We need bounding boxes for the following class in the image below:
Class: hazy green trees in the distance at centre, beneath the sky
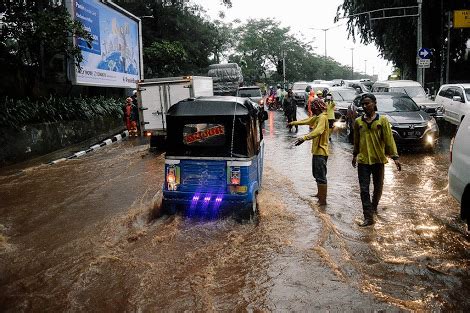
[229,18,362,83]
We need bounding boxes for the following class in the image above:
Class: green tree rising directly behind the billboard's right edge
[115,0,231,77]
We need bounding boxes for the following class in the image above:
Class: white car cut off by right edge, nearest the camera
[448,115,470,231]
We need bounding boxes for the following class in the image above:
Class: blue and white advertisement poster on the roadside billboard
[72,0,141,88]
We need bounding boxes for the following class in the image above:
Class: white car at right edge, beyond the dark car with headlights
[436,83,470,125]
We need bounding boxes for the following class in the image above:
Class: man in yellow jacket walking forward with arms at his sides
[352,93,401,227]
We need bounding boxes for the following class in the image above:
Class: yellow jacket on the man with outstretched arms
[292,112,329,156]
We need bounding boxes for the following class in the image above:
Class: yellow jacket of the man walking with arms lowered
[353,114,398,165]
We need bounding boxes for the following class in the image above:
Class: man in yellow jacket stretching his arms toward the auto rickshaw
[289,99,329,205]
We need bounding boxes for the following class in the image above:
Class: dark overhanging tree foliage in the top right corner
[338,0,470,82]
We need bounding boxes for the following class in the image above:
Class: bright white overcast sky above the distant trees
[191,0,392,80]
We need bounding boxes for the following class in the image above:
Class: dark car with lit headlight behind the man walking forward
[346,92,439,149]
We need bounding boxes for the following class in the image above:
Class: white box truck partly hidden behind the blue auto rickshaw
[137,76,214,148]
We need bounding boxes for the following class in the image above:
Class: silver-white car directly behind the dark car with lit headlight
[372,80,443,118]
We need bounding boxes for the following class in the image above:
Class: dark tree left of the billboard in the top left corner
[0,0,92,96]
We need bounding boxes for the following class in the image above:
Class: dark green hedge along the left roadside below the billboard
[0,96,124,129]
